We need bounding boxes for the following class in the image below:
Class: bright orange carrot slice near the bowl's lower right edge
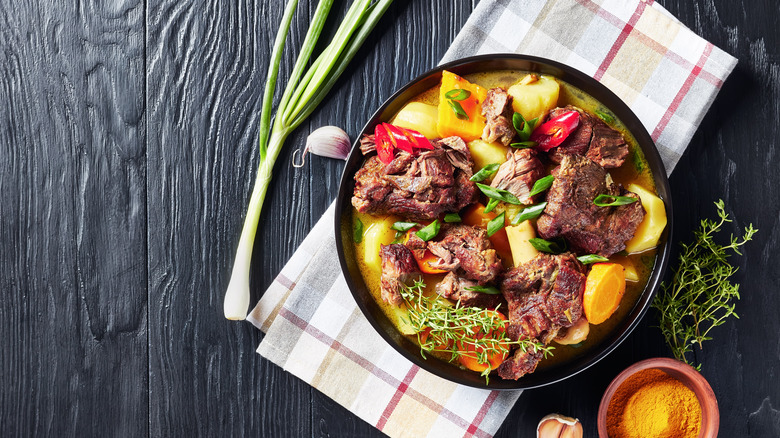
[582,263,626,324]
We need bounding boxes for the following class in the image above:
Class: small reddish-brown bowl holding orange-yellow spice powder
[598,357,720,438]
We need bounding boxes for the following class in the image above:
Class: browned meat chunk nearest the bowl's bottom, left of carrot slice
[498,253,586,379]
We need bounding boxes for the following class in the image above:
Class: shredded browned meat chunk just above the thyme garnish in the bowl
[428,224,502,285]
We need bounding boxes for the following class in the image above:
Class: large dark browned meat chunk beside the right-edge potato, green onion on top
[536,155,645,257]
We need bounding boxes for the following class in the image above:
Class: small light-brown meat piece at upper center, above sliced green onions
[490,149,544,204]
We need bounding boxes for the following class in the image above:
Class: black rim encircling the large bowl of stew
[334,53,673,390]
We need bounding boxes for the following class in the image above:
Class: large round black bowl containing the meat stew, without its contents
[335,54,673,389]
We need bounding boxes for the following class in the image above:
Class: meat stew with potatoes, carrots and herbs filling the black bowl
[351,71,666,380]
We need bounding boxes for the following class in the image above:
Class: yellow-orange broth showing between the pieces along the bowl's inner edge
[353,71,656,369]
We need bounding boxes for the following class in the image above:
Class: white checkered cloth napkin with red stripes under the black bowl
[248,0,736,437]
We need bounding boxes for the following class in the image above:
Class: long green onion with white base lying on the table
[224,0,392,320]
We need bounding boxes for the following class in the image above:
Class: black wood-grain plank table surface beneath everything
[0,0,780,437]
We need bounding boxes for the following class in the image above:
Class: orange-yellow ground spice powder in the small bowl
[607,369,701,438]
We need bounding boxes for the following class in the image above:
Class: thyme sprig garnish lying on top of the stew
[401,281,554,384]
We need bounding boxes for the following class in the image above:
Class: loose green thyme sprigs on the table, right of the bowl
[653,200,758,368]
